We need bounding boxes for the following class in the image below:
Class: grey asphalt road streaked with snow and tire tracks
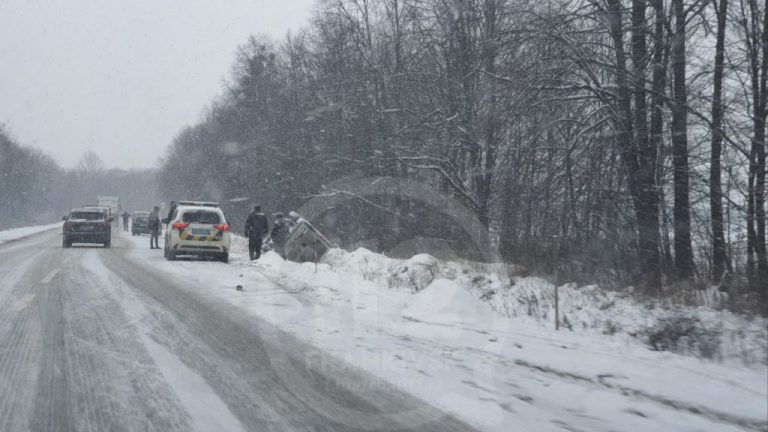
[0,230,471,431]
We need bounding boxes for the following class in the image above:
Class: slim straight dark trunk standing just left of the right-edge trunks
[709,0,728,282]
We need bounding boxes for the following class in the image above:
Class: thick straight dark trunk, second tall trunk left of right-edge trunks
[671,0,694,280]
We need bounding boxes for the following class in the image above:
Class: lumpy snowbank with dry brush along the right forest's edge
[322,248,768,369]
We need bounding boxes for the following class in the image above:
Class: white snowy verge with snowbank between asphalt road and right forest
[129,237,768,432]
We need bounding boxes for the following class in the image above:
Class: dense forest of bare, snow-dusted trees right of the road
[160,0,756,304]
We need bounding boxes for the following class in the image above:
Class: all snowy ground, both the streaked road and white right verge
[0,230,768,432]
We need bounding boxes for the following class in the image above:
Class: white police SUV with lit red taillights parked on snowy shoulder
[163,201,230,263]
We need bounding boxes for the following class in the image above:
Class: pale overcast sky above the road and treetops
[0,0,314,168]
